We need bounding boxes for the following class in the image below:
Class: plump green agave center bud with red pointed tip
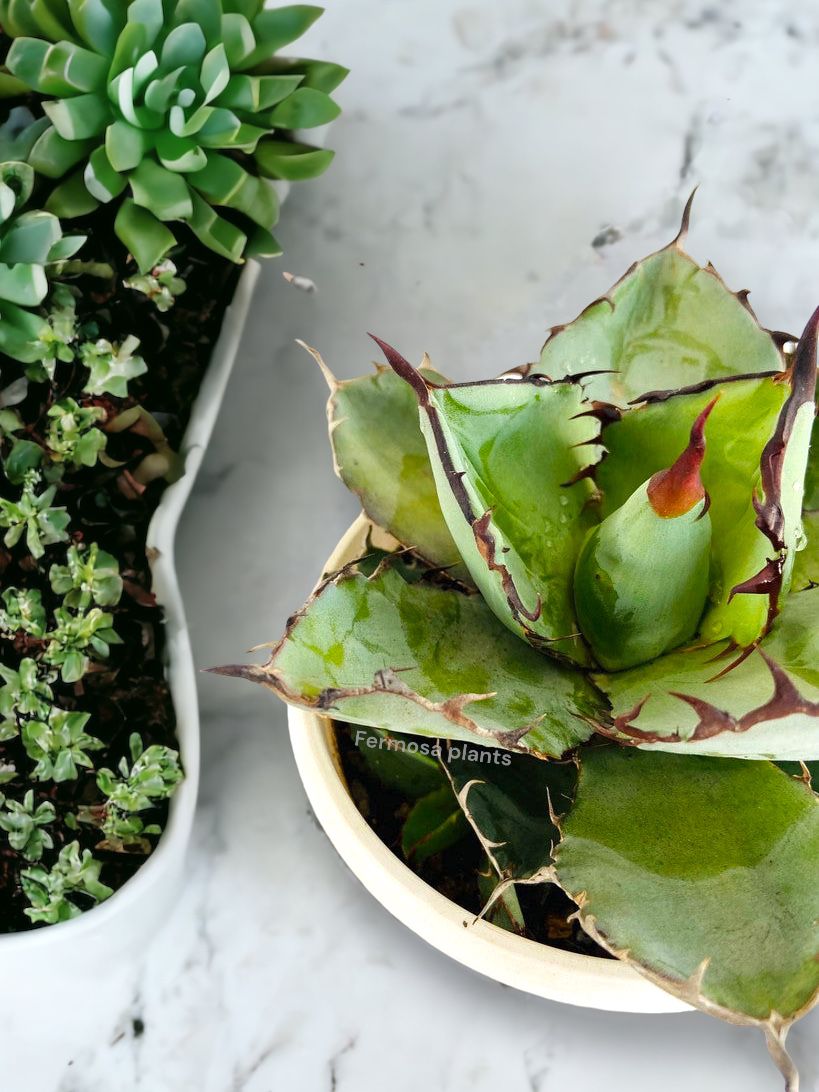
[574,399,716,672]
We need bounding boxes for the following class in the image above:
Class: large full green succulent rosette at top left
[0,0,346,274]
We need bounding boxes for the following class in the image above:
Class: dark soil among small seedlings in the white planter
[0,194,239,933]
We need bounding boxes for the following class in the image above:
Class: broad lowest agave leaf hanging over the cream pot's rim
[555,747,819,1088]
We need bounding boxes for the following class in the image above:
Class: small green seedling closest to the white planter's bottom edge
[20,842,114,925]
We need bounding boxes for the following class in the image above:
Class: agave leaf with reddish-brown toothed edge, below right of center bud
[594,589,819,761]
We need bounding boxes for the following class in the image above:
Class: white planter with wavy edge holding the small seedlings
[0,257,259,982]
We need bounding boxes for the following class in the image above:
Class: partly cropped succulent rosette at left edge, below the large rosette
[0,163,85,364]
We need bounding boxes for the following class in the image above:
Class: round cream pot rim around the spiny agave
[288,519,689,1012]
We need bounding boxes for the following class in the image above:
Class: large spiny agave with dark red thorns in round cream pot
[219,203,819,1089]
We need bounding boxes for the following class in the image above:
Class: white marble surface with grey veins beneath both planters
[11,0,819,1092]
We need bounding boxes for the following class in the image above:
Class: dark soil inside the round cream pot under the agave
[335,723,612,959]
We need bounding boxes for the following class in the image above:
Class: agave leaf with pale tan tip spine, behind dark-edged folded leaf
[309,349,461,566]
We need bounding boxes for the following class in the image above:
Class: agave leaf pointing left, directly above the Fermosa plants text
[224,559,600,756]
